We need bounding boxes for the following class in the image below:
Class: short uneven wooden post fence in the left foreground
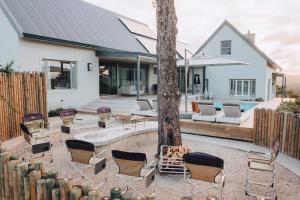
[0,149,103,200]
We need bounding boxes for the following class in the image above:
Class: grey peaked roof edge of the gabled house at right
[194,20,282,70]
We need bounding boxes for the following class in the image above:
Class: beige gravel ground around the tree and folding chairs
[4,129,300,200]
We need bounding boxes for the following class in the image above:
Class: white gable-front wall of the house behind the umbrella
[198,26,272,99]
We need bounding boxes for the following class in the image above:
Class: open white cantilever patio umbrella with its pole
[177,53,249,112]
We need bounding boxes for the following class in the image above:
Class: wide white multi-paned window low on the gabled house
[229,79,256,97]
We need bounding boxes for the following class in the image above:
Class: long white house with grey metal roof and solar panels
[0,0,186,109]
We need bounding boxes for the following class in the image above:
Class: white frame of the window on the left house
[42,58,78,91]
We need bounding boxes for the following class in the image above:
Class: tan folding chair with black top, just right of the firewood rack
[183,152,225,199]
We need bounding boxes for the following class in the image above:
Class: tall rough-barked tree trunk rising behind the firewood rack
[156,0,182,155]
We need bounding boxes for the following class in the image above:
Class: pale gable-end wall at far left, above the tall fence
[0,9,19,67]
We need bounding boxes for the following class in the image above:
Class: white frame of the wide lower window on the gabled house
[229,79,256,97]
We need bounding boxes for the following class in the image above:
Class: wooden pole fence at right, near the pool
[253,109,300,160]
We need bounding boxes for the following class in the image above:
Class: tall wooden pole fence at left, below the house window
[0,72,48,140]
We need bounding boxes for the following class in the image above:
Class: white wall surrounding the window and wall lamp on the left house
[19,39,99,110]
